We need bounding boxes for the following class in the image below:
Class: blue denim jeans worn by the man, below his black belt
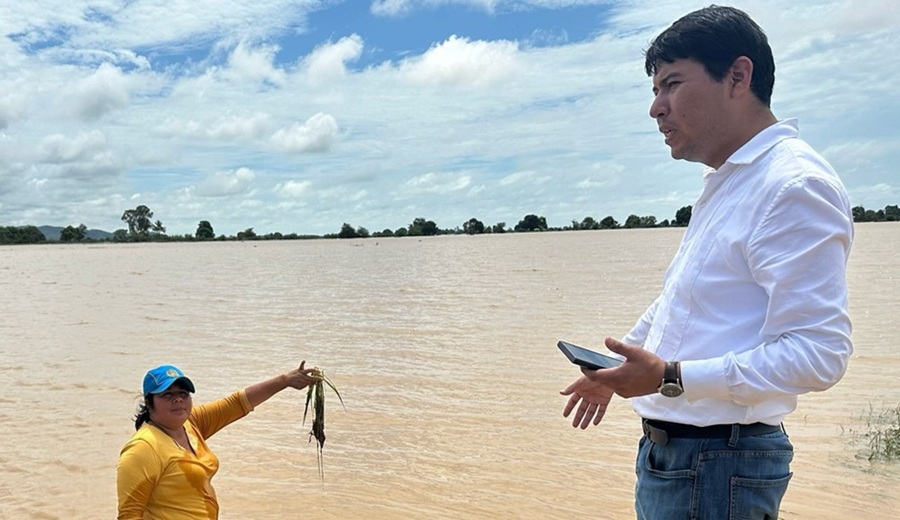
[635,424,794,520]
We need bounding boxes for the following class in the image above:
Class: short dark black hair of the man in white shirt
[644,5,775,106]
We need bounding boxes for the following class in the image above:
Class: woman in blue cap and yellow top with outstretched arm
[116,362,319,520]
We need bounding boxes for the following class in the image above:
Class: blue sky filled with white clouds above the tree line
[0,0,900,235]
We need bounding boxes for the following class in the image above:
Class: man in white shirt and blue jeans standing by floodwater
[562,6,853,520]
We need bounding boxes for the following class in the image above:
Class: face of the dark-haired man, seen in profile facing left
[650,59,733,168]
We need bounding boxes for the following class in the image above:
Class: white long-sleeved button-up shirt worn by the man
[623,120,853,426]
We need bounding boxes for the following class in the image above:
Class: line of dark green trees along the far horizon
[0,205,900,244]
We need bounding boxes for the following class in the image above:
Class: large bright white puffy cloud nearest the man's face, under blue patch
[400,35,518,86]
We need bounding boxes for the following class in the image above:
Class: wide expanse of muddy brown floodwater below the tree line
[0,224,900,520]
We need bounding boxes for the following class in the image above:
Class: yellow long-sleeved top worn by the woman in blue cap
[116,390,253,520]
